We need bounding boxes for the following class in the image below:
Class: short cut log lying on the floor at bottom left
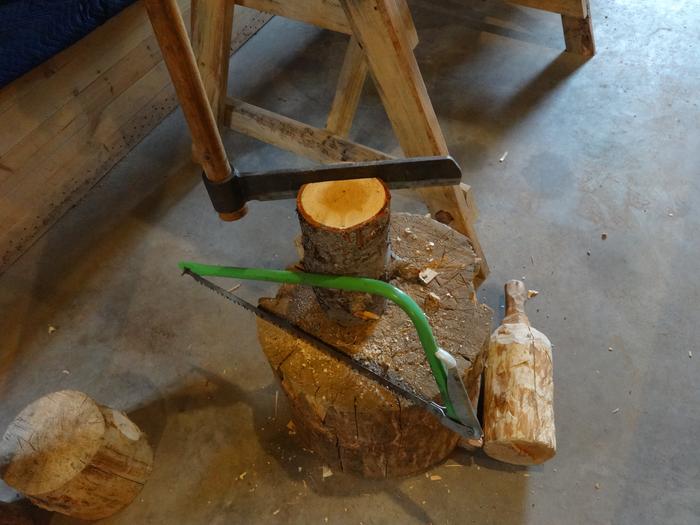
[0,390,153,520]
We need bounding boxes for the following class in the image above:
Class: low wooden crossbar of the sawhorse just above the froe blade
[226,99,391,163]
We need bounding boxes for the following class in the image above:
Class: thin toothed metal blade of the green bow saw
[183,270,456,426]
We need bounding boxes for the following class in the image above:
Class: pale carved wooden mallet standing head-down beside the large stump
[484,281,557,465]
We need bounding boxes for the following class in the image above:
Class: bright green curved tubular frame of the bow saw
[178,262,457,419]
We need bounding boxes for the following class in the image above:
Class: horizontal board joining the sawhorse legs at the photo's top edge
[235,0,352,35]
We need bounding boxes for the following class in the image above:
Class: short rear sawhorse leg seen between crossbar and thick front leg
[326,36,368,137]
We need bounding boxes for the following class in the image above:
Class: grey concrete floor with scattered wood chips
[0,0,700,525]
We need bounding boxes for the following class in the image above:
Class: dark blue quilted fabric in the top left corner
[0,0,135,87]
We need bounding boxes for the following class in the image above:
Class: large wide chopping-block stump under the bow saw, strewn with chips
[258,214,492,478]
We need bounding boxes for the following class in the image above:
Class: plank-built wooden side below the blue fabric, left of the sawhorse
[0,0,271,273]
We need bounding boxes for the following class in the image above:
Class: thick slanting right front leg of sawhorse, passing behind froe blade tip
[342,0,488,284]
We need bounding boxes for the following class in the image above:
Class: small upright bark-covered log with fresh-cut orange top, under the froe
[297,179,391,325]
